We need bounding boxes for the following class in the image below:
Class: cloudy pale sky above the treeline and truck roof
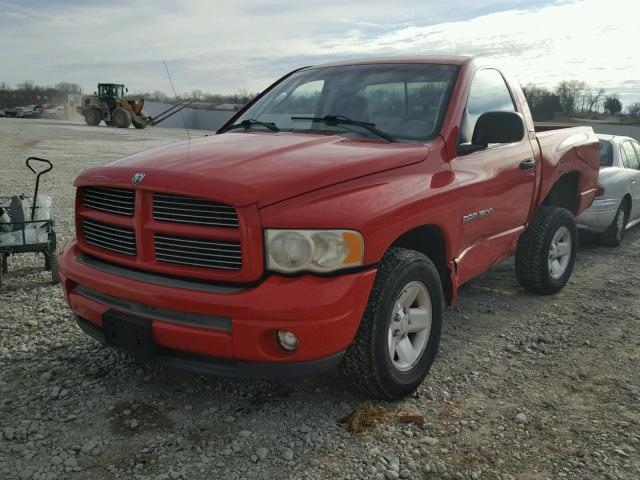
[0,0,640,104]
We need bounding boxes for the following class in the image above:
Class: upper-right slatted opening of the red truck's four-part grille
[153,193,238,228]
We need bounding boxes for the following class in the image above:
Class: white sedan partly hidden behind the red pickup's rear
[577,134,640,247]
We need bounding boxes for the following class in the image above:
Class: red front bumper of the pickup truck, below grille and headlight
[59,240,376,377]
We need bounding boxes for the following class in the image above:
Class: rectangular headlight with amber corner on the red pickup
[265,230,364,273]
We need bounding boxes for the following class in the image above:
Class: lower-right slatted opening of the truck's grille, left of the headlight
[154,234,242,270]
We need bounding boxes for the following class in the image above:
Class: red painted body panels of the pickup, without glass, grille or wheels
[60,57,599,372]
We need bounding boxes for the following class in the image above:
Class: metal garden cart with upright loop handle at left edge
[0,157,59,287]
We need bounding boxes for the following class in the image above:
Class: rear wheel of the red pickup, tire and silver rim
[516,207,578,295]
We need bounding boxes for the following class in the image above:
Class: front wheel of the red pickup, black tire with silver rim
[340,248,444,400]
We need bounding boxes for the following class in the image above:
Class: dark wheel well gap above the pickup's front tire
[391,225,451,298]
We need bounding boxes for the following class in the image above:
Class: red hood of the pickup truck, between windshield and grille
[76,132,428,207]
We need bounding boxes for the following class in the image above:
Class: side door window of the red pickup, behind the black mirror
[459,68,516,143]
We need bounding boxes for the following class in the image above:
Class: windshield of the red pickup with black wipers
[230,64,458,142]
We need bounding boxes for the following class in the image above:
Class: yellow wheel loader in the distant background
[77,83,194,128]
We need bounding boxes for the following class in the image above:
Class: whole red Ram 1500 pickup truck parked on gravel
[60,57,599,399]
